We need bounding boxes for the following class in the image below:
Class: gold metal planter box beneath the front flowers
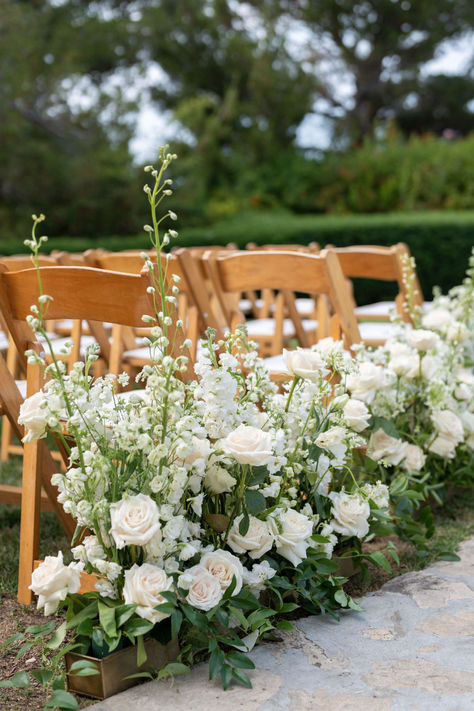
[65,639,179,700]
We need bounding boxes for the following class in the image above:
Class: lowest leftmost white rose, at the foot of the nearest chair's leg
[29,552,84,615]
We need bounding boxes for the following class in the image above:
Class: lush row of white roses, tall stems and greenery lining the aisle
[8,149,473,708]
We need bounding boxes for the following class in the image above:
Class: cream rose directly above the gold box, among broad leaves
[123,563,173,623]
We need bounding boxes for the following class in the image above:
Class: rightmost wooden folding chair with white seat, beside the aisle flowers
[325,243,423,346]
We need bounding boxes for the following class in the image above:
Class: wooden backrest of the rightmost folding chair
[325,242,423,319]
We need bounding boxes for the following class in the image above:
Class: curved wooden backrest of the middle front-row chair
[203,250,360,346]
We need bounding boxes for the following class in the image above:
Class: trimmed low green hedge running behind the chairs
[0,211,474,302]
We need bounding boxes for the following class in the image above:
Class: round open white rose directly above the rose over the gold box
[110,494,160,548]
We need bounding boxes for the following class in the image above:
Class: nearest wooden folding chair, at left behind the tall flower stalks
[0,266,192,603]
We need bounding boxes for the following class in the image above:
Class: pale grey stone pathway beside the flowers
[90,539,474,711]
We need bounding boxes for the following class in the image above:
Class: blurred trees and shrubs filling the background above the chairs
[0,0,474,272]
